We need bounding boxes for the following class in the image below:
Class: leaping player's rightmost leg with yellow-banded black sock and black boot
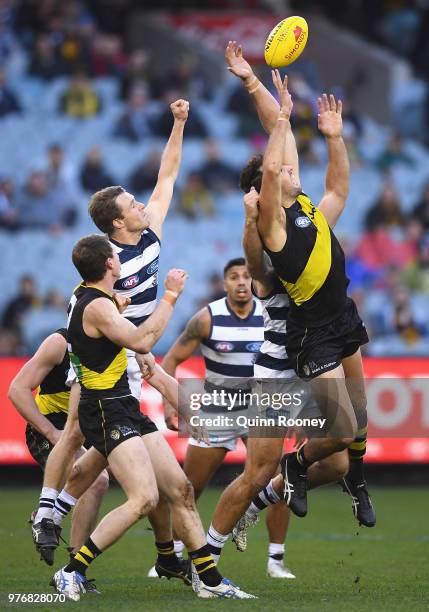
[342,349,376,527]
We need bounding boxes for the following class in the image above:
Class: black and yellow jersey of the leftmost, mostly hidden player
[34,328,70,415]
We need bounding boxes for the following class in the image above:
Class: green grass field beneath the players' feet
[0,487,429,612]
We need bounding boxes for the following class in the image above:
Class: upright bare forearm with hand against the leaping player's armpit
[243,187,274,295]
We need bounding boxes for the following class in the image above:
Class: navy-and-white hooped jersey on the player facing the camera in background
[201,298,264,385]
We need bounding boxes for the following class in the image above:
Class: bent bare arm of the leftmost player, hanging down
[8,334,67,444]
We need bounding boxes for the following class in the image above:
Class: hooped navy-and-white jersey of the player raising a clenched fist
[110,228,161,325]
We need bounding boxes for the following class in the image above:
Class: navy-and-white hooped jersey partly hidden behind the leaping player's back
[254,282,295,378]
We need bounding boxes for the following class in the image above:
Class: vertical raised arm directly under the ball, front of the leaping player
[257,70,292,251]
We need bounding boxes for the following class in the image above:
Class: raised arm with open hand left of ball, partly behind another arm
[225,40,299,179]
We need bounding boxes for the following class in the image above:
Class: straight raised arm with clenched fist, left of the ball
[146,100,189,238]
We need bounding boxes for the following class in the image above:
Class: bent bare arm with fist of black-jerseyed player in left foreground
[83,269,187,353]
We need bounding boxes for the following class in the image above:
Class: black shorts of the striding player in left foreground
[79,395,158,457]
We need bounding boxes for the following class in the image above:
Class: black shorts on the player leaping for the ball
[286,298,369,380]
